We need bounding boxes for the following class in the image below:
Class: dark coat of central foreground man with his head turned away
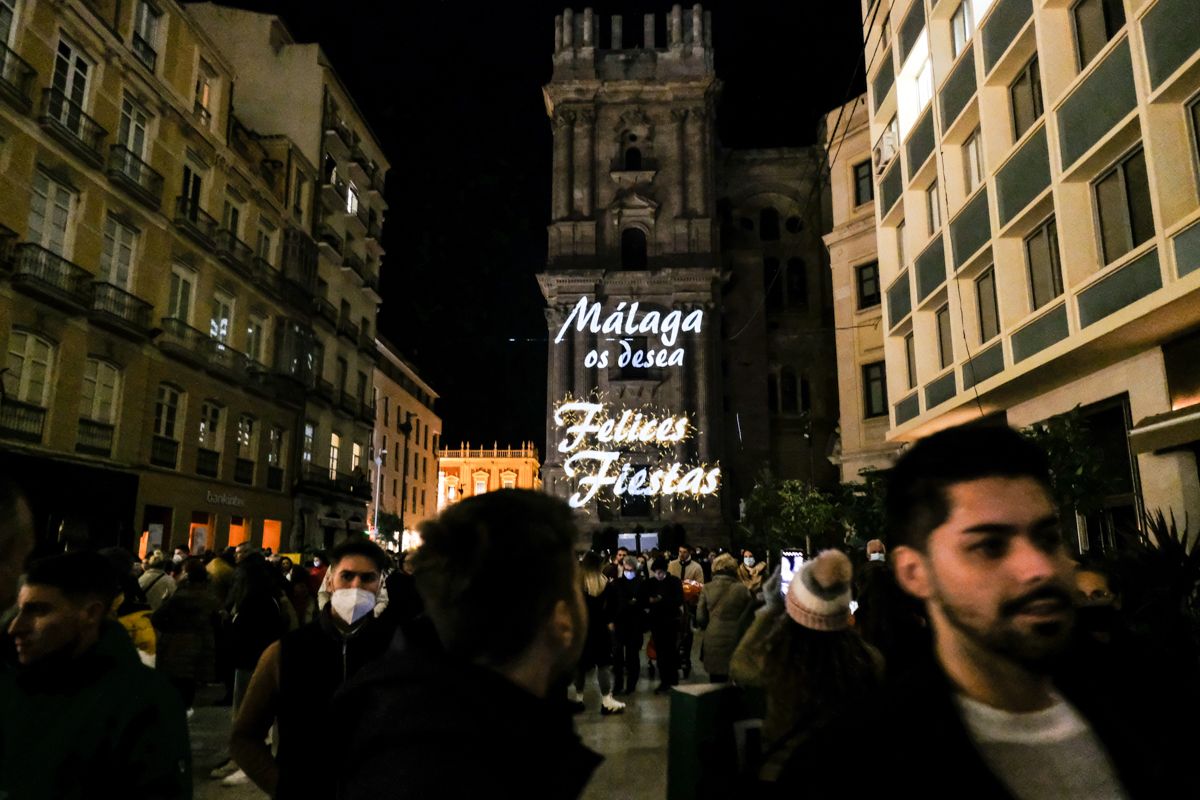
[336,648,602,800]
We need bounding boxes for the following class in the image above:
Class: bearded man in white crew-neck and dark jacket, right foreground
[781,426,1200,799]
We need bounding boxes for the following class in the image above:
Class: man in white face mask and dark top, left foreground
[230,539,395,800]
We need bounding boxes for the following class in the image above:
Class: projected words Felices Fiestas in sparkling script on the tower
[554,397,721,509]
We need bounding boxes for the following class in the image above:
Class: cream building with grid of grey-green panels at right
[863,0,1200,551]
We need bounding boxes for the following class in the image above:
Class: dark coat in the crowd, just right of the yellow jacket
[150,581,220,682]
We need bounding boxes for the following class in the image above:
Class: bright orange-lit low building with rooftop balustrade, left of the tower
[437,443,542,511]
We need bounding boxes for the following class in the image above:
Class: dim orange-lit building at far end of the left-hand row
[371,339,442,533]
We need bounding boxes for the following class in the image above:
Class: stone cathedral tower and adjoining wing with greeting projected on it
[539,6,836,543]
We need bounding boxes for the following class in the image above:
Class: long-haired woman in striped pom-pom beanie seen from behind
[730,551,883,781]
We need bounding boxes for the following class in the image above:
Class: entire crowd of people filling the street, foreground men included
[0,427,1200,799]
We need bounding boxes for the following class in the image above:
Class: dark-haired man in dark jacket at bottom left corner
[0,553,192,800]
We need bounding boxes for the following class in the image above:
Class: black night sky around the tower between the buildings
[216,0,863,447]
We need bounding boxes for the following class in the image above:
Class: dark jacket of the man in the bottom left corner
[0,620,192,800]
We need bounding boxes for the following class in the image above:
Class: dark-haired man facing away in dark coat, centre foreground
[326,489,601,800]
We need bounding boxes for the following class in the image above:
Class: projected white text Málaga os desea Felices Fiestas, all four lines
[554,297,721,509]
